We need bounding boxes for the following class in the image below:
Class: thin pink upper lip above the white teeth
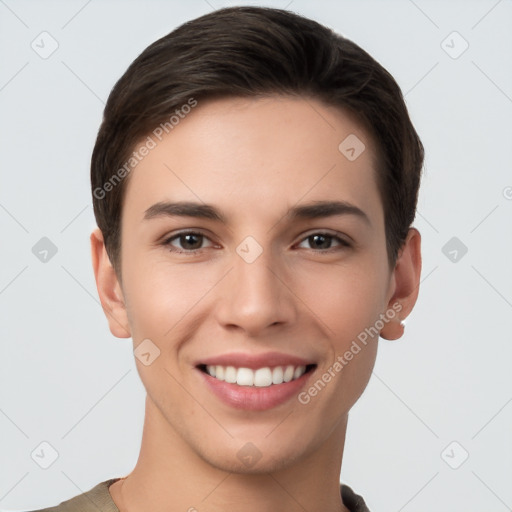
[195,352,316,370]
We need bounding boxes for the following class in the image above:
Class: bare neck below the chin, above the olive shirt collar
[110,397,349,512]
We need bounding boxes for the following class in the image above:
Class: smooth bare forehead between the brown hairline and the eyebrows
[123,96,383,229]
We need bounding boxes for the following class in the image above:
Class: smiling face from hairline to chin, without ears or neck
[109,97,394,472]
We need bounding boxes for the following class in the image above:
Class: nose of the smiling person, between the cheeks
[216,250,297,336]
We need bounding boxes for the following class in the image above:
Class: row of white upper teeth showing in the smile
[206,365,306,387]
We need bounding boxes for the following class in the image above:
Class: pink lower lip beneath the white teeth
[197,368,315,411]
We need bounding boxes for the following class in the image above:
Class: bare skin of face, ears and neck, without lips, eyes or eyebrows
[91,96,421,512]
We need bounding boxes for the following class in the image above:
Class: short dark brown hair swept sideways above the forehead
[91,7,424,278]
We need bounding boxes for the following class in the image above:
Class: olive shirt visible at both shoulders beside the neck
[31,478,370,512]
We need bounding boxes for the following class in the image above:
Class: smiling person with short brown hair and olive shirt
[29,7,424,512]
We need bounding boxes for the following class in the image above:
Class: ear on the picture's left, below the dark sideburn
[90,228,131,338]
